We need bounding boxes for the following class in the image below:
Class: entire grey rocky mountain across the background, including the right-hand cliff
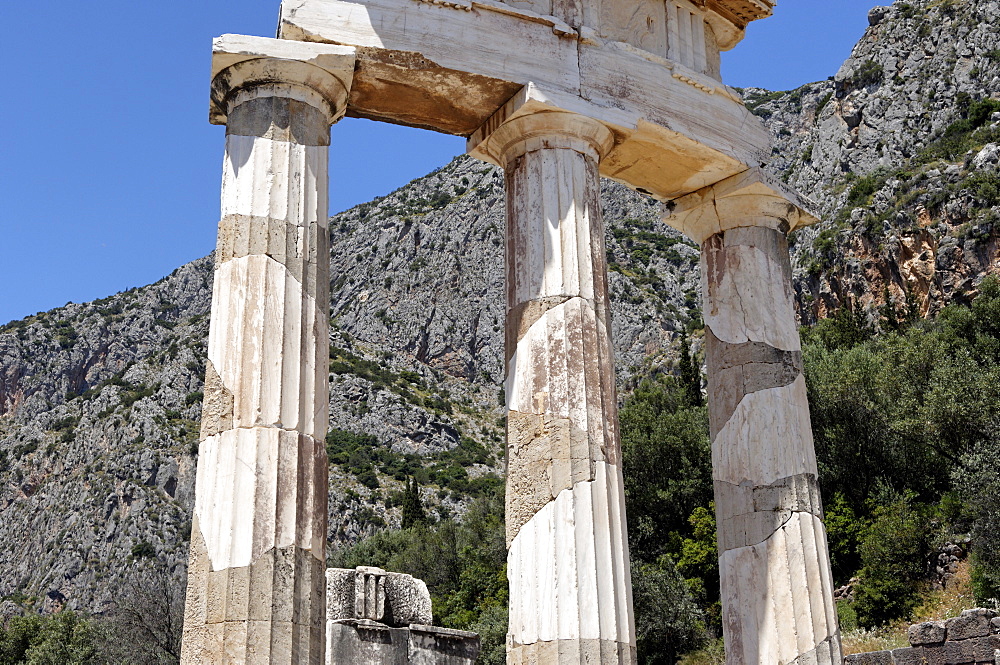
[0,0,1000,624]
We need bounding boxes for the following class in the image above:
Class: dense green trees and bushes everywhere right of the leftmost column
[333,278,1000,665]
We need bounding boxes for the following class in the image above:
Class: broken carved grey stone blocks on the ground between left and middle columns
[326,566,479,665]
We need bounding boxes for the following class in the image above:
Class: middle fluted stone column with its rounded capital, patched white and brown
[474,112,635,665]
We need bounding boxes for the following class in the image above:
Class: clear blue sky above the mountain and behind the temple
[0,0,876,324]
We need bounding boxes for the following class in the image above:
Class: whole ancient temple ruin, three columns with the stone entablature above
[182,0,841,665]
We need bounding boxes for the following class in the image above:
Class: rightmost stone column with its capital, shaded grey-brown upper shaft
[667,171,842,665]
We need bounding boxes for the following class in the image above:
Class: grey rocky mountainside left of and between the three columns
[0,157,698,613]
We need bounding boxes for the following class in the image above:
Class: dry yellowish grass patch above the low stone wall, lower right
[843,561,976,655]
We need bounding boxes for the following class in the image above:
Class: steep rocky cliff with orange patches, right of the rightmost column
[745,0,1000,322]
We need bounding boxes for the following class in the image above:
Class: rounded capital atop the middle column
[478,111,615,168]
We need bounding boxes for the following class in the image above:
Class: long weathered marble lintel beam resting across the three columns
[279,0,771,201]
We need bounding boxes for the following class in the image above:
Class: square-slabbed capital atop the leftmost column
[209,35,356,125]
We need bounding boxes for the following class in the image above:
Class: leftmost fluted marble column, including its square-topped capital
[181,36,354,665]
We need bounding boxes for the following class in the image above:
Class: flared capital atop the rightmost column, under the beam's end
[663,168,819,244]
